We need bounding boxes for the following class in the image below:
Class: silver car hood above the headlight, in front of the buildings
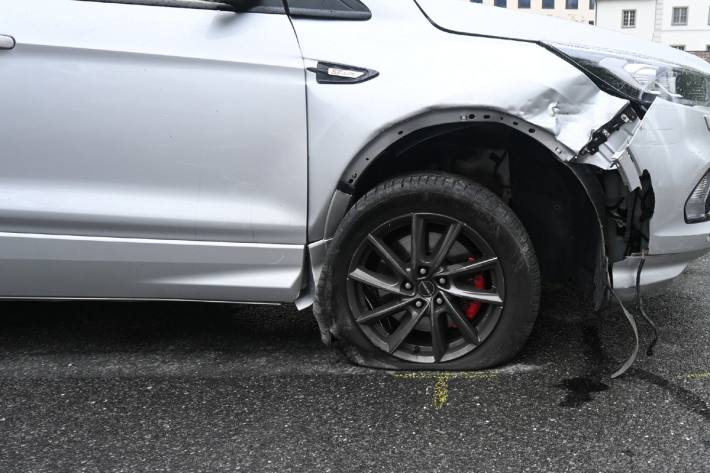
[415,0,710,74]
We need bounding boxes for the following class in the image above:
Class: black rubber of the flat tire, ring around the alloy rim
[322,176,539,370]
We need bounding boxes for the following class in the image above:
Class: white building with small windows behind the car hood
[596,0,710,51]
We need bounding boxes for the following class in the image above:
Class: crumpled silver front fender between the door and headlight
[293,0,628,241]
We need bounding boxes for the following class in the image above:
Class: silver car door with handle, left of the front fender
[0,0,307,301]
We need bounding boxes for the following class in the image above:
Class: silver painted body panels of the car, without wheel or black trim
[0,0,710,302]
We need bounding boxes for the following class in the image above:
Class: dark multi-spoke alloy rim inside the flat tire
[347,213,505,363]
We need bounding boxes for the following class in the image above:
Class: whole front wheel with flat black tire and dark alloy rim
[314,173,540,370]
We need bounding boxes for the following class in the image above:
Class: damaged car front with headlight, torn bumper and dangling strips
[551,43,710,377]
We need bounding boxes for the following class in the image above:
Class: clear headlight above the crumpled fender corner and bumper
[553,45,710,106]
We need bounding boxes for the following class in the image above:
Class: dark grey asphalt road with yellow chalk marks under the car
[0,258,710,473]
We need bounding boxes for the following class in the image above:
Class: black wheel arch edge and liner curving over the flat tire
[302,107,608,307]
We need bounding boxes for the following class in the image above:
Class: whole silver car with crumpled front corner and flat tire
[0,0,710,369]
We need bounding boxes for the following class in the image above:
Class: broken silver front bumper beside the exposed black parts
[612,100,710,298]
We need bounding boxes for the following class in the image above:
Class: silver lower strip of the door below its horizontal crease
[0,233,303,302]
